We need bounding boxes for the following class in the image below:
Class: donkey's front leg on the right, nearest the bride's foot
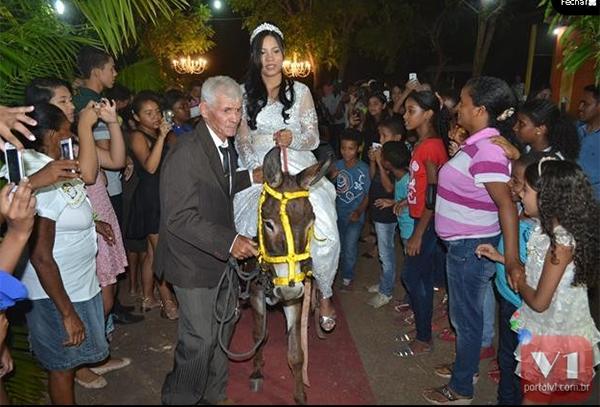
[283,302,308,404]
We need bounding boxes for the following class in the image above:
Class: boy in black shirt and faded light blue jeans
[367,117,404,308]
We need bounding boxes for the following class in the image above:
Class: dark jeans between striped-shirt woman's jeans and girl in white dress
[498,295,523,406]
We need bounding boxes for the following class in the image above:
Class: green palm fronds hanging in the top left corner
[0,0,195,105]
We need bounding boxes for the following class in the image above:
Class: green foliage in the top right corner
[539,0,600,84]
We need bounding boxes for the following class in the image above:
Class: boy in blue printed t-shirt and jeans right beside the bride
[331,129,371,291]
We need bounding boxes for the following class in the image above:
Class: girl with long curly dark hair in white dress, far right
[509,159,600,404]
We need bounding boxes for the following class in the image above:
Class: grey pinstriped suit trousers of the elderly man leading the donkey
[162,279,237,405]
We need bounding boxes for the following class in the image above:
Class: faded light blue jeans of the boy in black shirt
[373,222,398,297]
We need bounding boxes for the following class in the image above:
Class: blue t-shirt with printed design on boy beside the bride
[335,160,371,222]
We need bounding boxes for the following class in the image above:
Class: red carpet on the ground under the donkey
[227,303,375,405]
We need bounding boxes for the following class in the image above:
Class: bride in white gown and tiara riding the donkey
[234,23,340,332]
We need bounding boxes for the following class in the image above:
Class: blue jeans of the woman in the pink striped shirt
[445,236,499,397]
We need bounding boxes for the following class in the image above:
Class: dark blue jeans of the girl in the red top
[402,219,438,342]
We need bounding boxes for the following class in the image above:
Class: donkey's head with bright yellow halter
[258,147,332,300]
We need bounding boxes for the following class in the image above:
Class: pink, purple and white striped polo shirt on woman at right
[435,128,510,240]
